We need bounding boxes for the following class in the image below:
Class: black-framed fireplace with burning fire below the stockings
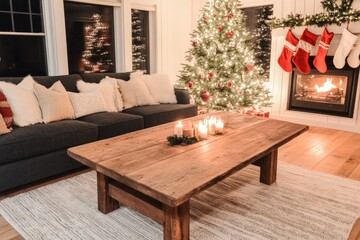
[288,57,359,118]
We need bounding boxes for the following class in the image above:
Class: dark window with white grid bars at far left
[0,0,47,76]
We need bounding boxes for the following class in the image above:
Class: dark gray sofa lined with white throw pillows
[0,73,197,192]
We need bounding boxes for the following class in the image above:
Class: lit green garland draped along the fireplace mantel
[267,0,360,28]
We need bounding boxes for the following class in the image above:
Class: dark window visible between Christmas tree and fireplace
[243,5,273,77]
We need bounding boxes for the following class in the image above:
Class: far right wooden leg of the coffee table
[259,149,278,185]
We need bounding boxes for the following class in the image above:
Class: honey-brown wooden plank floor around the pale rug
[0,127,360,240]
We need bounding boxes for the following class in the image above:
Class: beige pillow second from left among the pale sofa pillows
[34,81,75,123]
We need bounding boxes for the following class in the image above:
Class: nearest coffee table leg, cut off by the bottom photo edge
[163,200,190,240]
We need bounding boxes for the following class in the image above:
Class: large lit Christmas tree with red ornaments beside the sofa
[179,0,270,110]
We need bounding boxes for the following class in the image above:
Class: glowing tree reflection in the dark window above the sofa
[81,13,113,72]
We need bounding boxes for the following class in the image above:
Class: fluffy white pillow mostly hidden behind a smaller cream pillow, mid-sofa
[76,80,118,112]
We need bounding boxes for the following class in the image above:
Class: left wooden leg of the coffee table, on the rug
[97,172,119,214]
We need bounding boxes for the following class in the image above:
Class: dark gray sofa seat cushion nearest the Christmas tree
[123,104,197,128]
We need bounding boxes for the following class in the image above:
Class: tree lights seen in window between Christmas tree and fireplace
[254,5,273,77]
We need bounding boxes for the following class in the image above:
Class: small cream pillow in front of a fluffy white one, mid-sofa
[68,90,107,118]
